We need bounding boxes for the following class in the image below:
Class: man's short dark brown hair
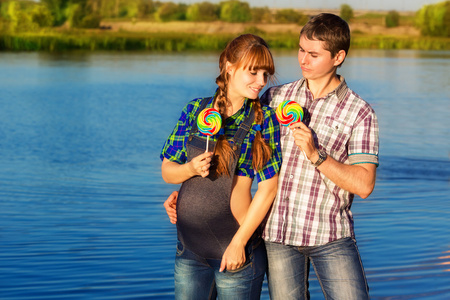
[300,13,350,63]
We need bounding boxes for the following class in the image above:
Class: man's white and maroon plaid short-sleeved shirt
[261,76,378,246]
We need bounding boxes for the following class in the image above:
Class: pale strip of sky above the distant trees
[174,0,444,11]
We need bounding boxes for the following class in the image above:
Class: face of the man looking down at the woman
[298,35,340,80]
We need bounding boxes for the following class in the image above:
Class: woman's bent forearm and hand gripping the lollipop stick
[161,152,213,184]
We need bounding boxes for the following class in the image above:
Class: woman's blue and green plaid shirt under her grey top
[160,98,281,182]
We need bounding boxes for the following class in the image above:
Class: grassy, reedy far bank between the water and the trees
[0,16,450,52]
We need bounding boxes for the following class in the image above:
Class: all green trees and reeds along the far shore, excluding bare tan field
[0,0,450,51]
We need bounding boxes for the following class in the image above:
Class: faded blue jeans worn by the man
[265,238,369,300]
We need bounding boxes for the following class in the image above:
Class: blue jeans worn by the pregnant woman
[175,238,267,300]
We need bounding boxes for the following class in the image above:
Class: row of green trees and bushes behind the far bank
[0,0,450,37]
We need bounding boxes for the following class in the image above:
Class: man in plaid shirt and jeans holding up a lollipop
[261,14,378,300]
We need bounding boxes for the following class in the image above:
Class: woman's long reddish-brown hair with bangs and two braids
[214,34,275,176]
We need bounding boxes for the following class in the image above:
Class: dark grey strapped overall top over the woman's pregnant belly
[177,98,254,259]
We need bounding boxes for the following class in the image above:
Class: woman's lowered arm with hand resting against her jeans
[220,175,278,272]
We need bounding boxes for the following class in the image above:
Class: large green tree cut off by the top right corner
[415,1,450,37]
